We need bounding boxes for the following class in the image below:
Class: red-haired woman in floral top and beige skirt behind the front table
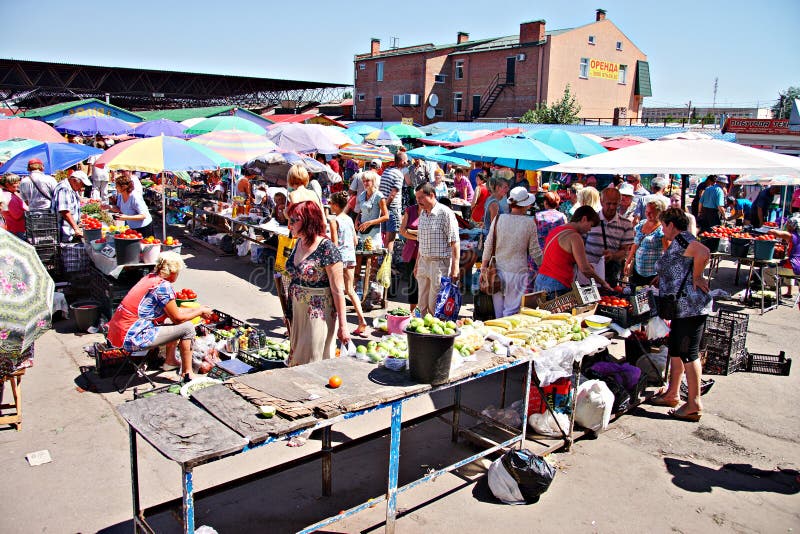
[286,201,350,366]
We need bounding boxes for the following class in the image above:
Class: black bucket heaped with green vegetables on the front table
[406,330,460,386]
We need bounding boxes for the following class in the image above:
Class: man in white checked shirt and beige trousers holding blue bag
[414,182,460,315]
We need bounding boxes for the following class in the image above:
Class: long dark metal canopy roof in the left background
[0,59,352,111]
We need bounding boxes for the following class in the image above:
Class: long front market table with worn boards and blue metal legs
[118,350,533,534]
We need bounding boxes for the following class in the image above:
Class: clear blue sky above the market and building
[0,0,800,107]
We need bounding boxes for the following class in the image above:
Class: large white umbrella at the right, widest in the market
[540,139,800,176]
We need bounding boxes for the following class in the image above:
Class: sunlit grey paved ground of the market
[0,240,800,533]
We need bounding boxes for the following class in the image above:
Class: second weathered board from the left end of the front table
[194,384,316,444]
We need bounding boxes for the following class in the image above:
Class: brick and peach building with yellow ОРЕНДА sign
[353,9,651,124]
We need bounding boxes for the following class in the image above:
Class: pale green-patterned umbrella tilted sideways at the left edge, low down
[0,229,55,374]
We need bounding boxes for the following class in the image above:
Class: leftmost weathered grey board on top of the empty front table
[117,393,247,464]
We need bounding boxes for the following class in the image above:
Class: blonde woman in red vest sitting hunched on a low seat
[108,252,213,382]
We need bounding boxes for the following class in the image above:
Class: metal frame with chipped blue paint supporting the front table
[129,359,533,534]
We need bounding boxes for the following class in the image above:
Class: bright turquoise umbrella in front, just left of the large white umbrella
[445,135,575,171]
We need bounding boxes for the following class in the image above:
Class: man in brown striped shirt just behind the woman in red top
[586,187,633,286]
